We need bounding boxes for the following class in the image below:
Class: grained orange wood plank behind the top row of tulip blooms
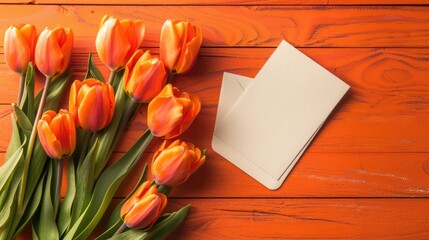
[0,5,429,48]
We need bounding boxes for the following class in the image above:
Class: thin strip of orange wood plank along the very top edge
[2,0,428,6]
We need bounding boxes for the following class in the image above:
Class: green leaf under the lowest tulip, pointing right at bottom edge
[110,205,191,240]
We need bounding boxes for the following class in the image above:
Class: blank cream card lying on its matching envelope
[212,41,349,189]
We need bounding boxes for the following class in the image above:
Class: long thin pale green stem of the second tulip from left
[18,77,51,212]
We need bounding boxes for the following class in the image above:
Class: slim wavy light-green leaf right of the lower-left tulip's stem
[57,158,76,236]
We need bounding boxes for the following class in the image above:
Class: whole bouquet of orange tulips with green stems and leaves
[0,16,205,239]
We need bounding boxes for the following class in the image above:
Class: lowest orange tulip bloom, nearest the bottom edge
[121,181,167,229]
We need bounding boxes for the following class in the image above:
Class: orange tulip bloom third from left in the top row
[95,15,145,70]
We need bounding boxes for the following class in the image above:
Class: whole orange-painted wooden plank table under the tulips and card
[0,0,429,239]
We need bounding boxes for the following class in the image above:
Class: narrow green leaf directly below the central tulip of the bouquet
[71,141,99,224]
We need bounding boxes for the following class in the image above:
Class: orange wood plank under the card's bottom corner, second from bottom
[113,153,429,198]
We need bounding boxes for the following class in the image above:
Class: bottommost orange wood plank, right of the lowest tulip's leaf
[155,199,429,240]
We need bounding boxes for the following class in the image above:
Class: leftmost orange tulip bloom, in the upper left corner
[4,24,37,74]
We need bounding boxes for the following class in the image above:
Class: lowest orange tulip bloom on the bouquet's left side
[37,109,76,160]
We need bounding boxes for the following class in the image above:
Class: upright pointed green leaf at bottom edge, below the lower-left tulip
[36,161,60,240]
